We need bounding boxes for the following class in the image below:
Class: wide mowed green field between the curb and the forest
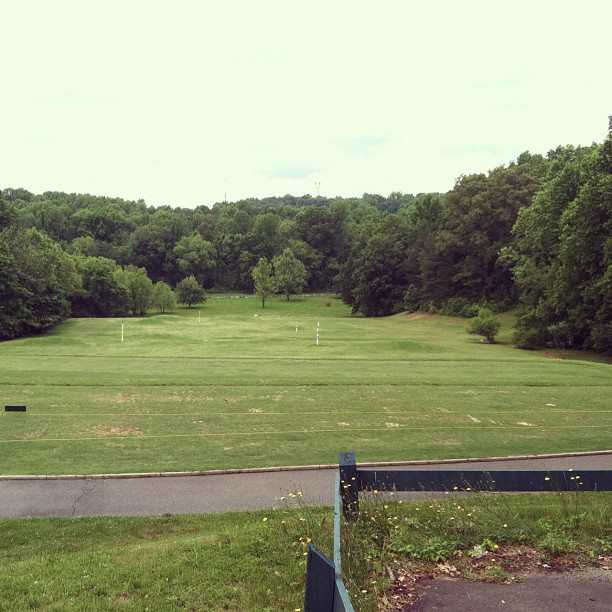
[0,296,612,474]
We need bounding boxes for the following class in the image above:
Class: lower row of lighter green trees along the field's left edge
[0,227,206,340]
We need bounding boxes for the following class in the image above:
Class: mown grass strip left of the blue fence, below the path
[0,510,331,611]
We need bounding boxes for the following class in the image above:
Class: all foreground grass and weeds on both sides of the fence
[0,493,612,612]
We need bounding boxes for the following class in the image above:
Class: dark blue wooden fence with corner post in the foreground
[304,452,612,612]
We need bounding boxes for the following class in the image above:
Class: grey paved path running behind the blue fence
[0,453,612,518]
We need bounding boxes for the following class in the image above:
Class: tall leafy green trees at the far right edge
[502,136,612,354]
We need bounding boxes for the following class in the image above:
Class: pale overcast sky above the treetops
[0,0,612,206]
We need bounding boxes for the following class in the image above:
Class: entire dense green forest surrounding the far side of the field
[0,124,612,352]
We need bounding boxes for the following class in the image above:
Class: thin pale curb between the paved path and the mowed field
[0,449,612,481]
